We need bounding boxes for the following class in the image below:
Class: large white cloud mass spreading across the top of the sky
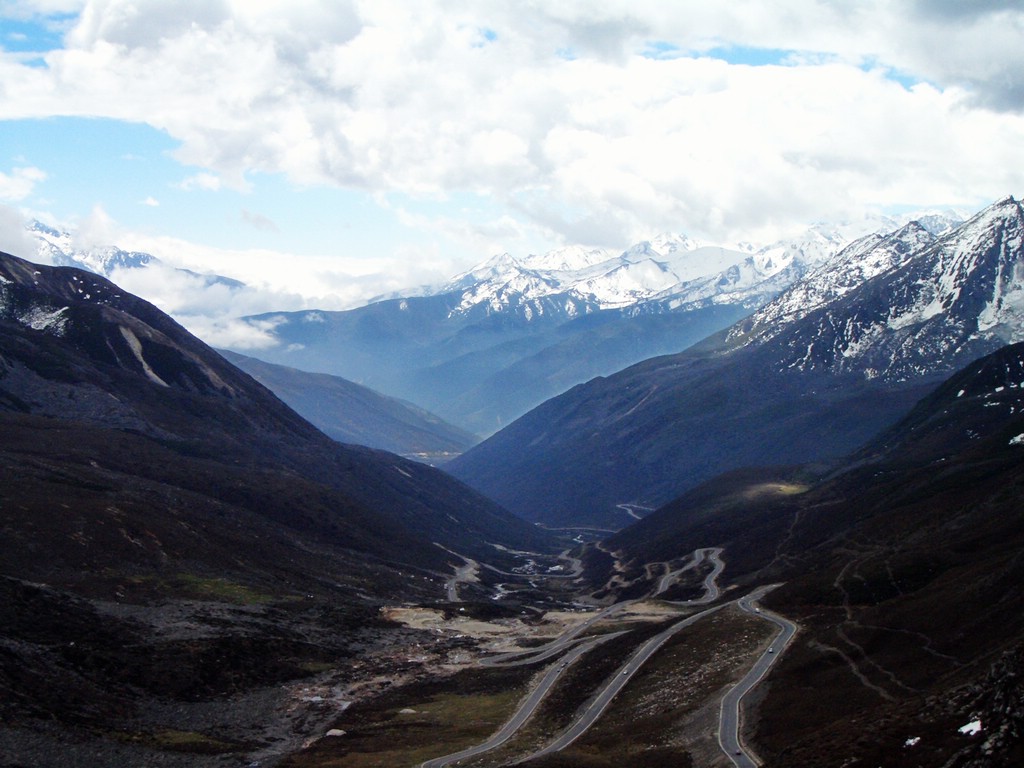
[0,0,1024,252]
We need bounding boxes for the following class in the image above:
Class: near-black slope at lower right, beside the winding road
[605,344,1024,768]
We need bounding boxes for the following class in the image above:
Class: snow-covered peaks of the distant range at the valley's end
[423,212,961,319]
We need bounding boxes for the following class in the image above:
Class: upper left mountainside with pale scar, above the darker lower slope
[0,249,543,555]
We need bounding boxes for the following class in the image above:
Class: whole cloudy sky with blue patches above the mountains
[0,0,1024,341]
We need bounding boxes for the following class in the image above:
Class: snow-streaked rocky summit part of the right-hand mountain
[734,198,1024,382]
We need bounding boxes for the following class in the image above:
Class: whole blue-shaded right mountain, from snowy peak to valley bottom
[447,199,1024,526]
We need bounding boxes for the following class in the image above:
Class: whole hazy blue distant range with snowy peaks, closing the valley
[232,214,955,435]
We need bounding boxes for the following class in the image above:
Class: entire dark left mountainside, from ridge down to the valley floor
[0,255,561,768]
